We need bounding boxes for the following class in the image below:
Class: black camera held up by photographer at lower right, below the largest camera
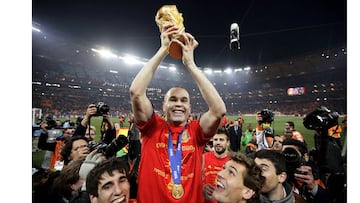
[282,148,306,176]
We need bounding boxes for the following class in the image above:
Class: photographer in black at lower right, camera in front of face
[282,139,331,203]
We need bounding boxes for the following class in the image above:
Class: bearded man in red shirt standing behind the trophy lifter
[202,127,230,203]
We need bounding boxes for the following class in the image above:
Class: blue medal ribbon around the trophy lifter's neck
[168,125,187,184]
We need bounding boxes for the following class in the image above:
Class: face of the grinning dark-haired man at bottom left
[90,170,130,203]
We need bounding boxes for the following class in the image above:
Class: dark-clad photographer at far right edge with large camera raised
[303,106,347,202]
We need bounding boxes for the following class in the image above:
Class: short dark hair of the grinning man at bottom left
[86,157,130,197]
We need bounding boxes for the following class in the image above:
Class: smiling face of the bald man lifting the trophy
[163,88,190,125]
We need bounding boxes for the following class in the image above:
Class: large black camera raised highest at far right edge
[303,106,339,130]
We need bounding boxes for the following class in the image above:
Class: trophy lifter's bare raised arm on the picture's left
[130,26,177,123]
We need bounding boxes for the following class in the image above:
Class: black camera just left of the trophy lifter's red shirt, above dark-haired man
[89,135,129,158]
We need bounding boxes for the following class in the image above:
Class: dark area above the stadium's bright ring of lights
[32,0,347,68]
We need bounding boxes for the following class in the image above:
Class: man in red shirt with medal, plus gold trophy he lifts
[130,5,226,203]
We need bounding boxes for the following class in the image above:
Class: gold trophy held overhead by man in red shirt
[155,5,185,59]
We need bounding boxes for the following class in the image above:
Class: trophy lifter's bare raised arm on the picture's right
[173,33,226,137]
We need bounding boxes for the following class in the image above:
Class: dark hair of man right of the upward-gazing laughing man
[254,149,286,175]
